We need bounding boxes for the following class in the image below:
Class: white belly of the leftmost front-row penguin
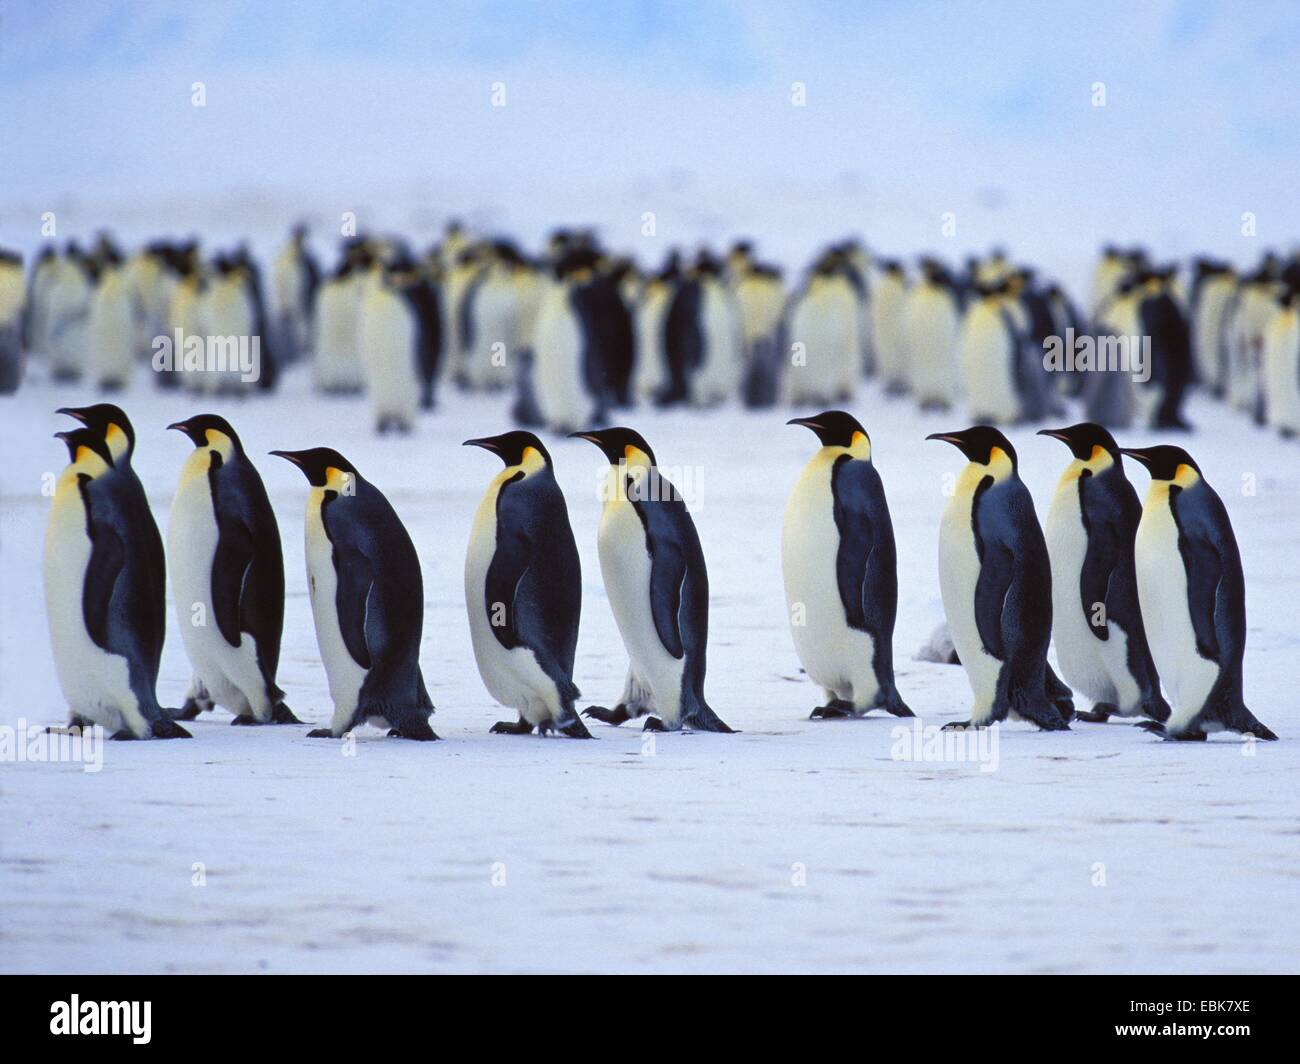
[44,485,148,735]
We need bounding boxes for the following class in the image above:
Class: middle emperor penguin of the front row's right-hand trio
[1039,421,1169,723]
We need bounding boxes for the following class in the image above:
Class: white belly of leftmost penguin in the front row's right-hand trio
[939,493,1002,725]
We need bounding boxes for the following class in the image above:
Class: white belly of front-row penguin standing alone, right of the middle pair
[781,458,879,708]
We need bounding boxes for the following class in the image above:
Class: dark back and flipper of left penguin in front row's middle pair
[485,470,582,702]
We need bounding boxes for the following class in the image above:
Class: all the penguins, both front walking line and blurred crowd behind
[15,225,1300,740]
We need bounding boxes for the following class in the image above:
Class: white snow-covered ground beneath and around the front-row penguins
[0,372,1300,972]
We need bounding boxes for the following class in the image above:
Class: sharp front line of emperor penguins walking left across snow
[44,403,1277,740]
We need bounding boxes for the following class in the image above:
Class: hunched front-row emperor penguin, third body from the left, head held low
[272,447,438,740]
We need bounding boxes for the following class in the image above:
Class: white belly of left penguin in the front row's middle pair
[465,492,560,726]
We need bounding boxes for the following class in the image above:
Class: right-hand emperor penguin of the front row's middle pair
[573,428,732,732]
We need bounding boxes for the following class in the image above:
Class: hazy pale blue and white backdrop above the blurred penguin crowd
[0,0,1300,275]
